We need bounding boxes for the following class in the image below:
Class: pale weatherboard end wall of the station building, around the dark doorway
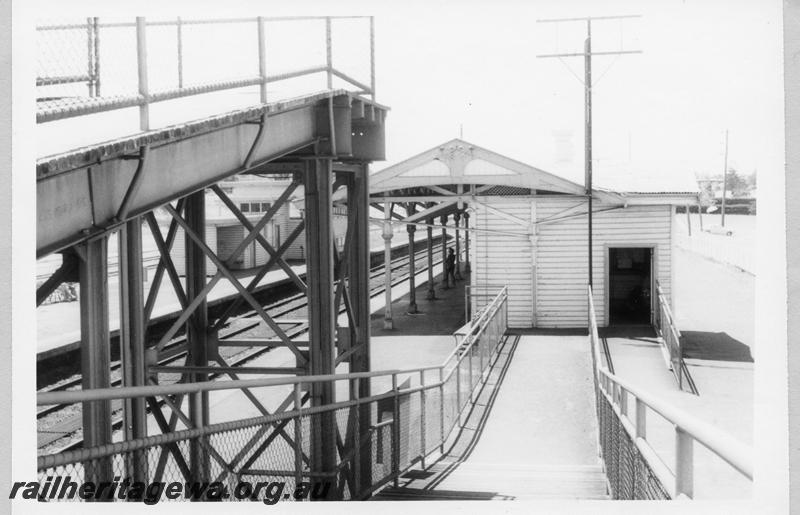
[471,195,672,328]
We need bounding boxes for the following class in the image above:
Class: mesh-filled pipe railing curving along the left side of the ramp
[37,288,508,500]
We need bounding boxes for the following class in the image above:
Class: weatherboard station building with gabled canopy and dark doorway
[370,139,699,328]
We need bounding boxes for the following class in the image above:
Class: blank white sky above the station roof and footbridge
[23,0,783,187]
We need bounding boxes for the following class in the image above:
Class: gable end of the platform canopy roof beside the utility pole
[370,138,584,195]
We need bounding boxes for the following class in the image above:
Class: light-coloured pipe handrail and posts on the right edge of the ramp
[588,287,753,499]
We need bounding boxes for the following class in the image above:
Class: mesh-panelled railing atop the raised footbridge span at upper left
[36,16,375,125]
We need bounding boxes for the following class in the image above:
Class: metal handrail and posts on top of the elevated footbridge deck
[36,16,375,124]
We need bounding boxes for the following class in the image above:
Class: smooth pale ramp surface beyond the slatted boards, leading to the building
[442,335,597,472]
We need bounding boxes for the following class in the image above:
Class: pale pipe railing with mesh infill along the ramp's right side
[588,287,753,499]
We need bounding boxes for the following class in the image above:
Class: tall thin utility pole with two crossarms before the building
[537,14,641,294]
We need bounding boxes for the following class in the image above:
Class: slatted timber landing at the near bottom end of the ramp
[373,462,609,501]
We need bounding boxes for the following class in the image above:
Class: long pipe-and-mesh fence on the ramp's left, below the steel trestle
[37,288,508,498]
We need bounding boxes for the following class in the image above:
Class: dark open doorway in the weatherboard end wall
[608,247,653,325]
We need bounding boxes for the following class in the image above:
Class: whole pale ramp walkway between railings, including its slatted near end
[377,334,608,500]
